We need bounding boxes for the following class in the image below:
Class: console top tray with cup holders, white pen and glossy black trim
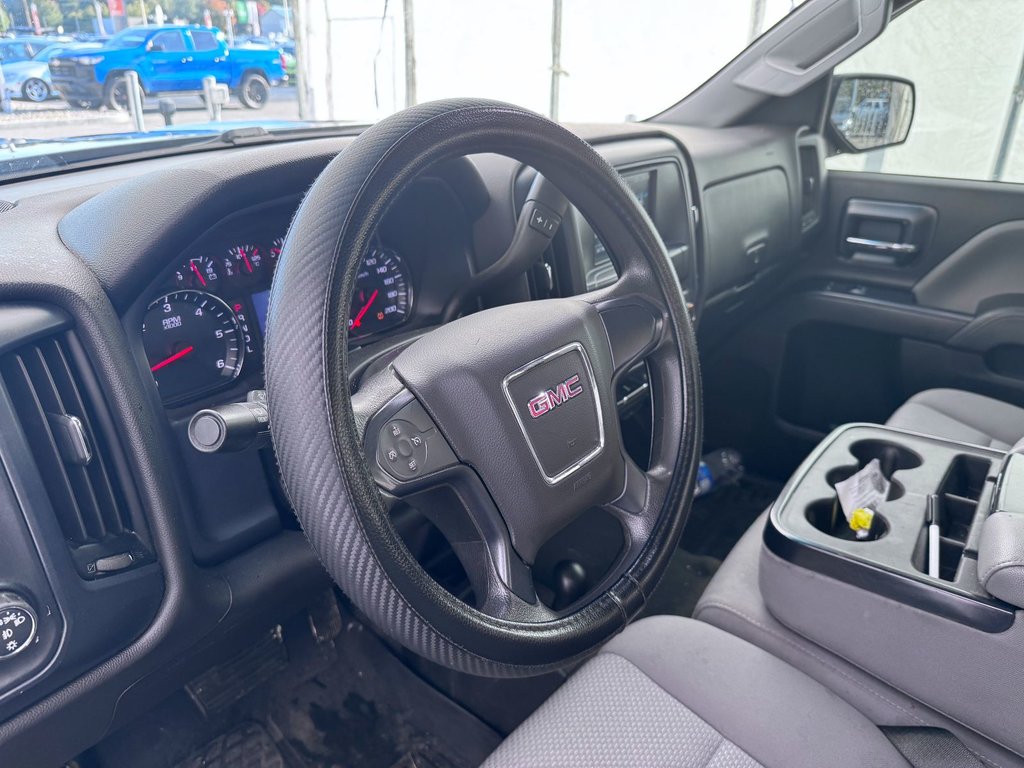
[765,424,1014,632]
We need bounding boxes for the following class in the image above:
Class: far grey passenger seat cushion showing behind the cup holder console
[887,389,1024,451]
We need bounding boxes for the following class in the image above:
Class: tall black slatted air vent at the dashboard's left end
[0,333,153,579]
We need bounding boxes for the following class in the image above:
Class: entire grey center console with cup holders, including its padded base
[756,424,1024,764]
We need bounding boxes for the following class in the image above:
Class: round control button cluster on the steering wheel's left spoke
[377,400,456,482]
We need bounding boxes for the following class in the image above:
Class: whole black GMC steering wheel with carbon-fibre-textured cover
[266,99,700,677]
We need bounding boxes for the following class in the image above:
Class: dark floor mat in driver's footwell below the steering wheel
[86,607,501,768]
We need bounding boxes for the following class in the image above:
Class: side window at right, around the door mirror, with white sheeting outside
[827,0,1024,182]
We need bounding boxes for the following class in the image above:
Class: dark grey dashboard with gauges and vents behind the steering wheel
[0,125,822,764]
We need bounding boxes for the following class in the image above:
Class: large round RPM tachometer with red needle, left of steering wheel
[142,291,245,402]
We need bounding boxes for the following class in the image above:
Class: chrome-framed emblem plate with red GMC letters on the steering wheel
[503,342,604,485]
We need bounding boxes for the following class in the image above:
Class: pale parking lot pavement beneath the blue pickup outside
[0,86,299,138]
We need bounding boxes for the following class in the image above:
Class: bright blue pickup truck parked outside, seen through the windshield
[49,25,288,110]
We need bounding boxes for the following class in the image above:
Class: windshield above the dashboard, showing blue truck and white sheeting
[0,0,801,172]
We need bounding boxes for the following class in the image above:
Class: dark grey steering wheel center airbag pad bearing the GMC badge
[392,300,626,563]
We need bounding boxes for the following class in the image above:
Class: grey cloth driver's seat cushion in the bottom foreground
[484,616,908,768]
